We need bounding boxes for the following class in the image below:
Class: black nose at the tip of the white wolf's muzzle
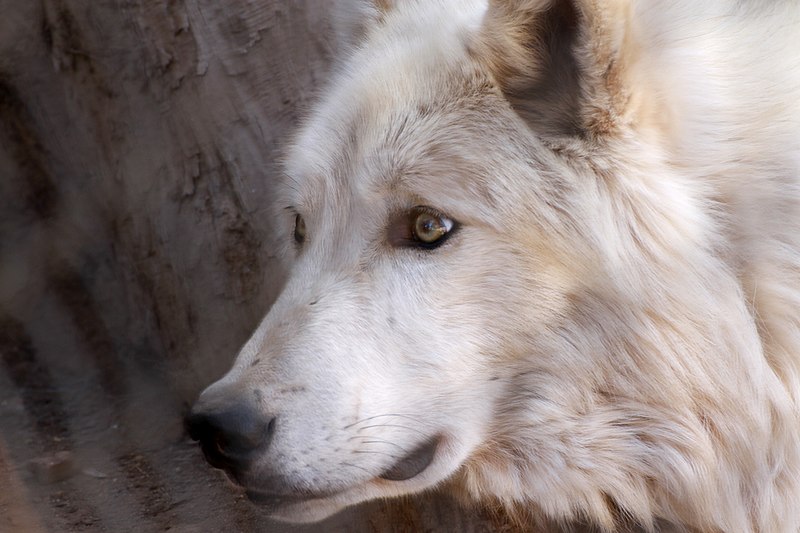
[186,405,275,474]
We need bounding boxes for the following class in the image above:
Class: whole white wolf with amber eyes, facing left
[190,0,800,533]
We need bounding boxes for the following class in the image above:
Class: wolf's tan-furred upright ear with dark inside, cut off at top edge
[476,0,631,136]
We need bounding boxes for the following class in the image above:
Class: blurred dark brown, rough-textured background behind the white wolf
[0,0,502,533]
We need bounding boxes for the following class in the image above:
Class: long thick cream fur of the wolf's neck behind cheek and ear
[462,2,800,532]
